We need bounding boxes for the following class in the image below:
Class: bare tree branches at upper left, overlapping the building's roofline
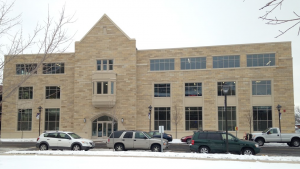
[0,1,73,105]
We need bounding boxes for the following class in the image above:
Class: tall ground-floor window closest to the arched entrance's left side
[45,108,60,130]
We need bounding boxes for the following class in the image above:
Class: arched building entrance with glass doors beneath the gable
[92,116,118,139]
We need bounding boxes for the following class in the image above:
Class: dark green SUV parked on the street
[190,131,260,155]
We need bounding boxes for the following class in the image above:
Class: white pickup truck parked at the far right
[250,127,300,147]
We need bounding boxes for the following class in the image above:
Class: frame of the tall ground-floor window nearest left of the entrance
[44,108,60,131]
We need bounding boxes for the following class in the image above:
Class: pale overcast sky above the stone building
[2,0,300,107]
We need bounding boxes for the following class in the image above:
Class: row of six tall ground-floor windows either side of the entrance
[17,106,272,131]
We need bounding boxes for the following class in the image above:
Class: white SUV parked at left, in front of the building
[36,131,95,151]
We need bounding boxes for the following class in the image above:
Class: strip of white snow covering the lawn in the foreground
[0,156,300,169]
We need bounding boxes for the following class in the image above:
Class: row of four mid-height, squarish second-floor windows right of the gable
[154,80,271,97]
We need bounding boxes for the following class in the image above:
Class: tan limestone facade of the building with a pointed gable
[1,15,294,139]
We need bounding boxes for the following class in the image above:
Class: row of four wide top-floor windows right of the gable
[150,53,275,71]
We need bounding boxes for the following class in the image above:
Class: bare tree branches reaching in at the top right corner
[259,0,300,38]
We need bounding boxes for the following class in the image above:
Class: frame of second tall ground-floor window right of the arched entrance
[184,107,203,131]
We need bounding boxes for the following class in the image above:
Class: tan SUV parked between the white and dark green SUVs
[106,130,169,152]
